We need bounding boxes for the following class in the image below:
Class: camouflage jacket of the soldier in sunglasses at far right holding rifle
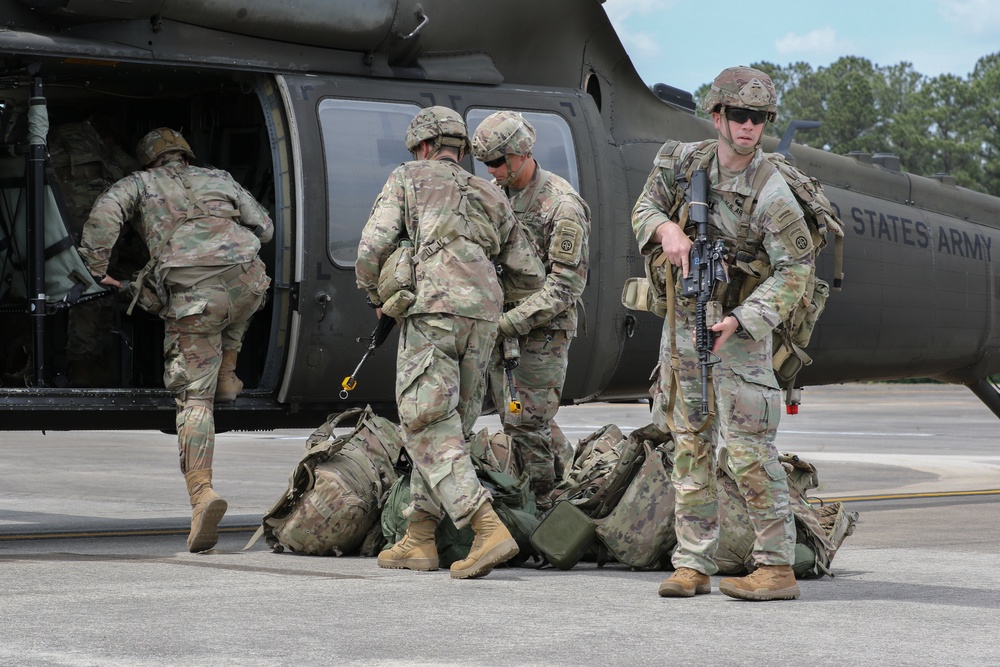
[632,143,813,341]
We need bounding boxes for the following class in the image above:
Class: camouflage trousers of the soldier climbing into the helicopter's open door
[161,259,271,473]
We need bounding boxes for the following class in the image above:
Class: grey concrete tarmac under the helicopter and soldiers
[0,385,1000,667]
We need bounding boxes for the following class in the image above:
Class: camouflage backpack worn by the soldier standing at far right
[622,139,844,387]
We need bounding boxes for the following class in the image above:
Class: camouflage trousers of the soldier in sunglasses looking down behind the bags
[489,329,574,493]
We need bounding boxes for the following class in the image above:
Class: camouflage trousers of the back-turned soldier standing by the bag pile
[396,313,497,528]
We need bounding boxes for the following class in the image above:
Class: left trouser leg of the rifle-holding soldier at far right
[654,308,719,575]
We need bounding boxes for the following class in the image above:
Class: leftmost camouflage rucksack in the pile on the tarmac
[245,406,403,556]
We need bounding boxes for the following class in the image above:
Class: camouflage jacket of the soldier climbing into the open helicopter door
[80,162,274,275]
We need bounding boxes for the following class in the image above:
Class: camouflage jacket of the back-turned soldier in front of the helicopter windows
[355,159,544,322]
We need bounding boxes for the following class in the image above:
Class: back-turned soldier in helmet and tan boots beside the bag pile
[356,107,542,579]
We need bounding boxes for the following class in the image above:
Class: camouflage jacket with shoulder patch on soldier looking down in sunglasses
[505,162,590,335]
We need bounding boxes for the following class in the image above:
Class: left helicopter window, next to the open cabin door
[319,98,420,268]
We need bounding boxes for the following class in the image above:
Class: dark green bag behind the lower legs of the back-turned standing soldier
[381,429,539,567]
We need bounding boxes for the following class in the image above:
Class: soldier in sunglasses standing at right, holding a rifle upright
[632,67,812,600]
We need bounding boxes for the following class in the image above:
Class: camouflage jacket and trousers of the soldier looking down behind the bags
[490,163,590,495]
